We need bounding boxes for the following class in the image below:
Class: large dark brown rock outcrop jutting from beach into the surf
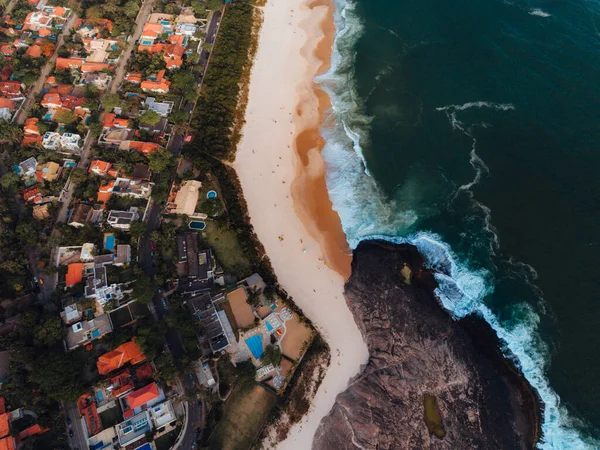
[313,242,540,450]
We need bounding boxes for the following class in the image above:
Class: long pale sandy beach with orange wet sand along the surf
[234,0,368,449]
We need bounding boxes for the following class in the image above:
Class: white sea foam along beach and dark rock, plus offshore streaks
[316,0,598,450]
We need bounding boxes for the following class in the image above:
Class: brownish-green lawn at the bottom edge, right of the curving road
[208,382,277,450]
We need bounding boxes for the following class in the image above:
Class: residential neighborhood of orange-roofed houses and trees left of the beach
[0,0,328,450]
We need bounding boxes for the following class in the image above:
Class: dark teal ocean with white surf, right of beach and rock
[317,0,600,450]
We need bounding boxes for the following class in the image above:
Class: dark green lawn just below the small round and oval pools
[202,220,252,278]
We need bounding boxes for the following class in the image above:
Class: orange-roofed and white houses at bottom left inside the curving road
[77,338,180,450]
